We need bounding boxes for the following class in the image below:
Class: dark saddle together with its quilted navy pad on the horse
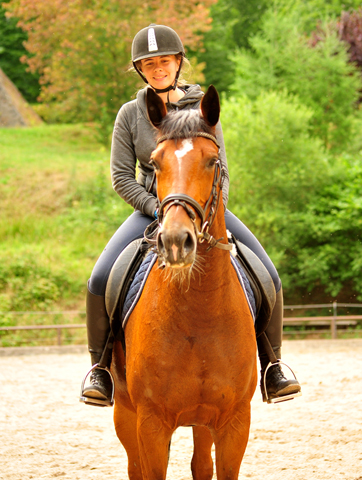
[105,238,276,345]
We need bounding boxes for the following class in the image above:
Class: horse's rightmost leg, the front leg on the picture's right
[213,403,250,480]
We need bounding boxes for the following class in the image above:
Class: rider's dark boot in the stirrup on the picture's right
[258,289,301,403]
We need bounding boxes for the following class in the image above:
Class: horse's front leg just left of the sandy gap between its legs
[137,410,173,480]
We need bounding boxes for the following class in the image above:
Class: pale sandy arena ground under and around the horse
[0,340,362,480]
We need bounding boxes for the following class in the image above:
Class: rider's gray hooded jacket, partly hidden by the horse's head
[111,85,229,217]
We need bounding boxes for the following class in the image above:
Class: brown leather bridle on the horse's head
[145,132,233,251]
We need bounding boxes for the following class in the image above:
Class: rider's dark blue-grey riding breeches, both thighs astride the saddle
[88,210,281,296]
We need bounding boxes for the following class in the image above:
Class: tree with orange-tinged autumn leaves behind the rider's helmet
[4,0,214,143]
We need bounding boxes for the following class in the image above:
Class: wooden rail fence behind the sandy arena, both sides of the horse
[0,302,362,345]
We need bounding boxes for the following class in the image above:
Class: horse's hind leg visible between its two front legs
[191,427,214,480]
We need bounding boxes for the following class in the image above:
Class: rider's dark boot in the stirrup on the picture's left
[80,288,113,407]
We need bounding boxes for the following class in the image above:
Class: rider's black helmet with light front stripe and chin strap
[132,23,185,93]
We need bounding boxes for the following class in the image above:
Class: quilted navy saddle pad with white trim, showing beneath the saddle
[121,252,256,328]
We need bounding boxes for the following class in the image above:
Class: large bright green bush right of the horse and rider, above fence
[222,87,362,300]
